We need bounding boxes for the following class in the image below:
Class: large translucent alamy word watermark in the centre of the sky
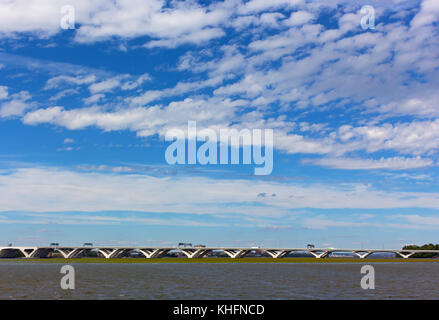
[165,121,273,175]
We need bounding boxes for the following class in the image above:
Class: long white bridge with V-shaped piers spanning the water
[0,246,439,259]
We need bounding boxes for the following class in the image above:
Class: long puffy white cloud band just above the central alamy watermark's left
[23,98,245,136]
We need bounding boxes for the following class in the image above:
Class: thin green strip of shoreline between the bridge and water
[0,258,439,264]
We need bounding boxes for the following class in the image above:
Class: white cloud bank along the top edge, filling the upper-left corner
[0,0,229,46]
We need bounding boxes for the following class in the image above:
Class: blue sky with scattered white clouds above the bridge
[0,0,439,248]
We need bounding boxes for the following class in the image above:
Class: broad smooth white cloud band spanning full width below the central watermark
[0,168,439,217]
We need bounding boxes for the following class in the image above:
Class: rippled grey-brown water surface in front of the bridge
[0,261,439,299]
